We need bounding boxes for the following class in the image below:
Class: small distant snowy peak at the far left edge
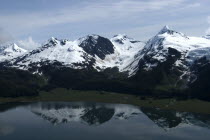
[0,44,27,62]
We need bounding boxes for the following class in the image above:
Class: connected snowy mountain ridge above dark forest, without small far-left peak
[0,25,210,76]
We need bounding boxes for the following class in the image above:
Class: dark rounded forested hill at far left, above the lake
[0,68,42,97]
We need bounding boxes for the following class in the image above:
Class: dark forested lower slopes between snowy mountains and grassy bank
[0,58,210,100]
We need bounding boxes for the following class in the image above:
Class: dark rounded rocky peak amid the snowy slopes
[79,35,114,59]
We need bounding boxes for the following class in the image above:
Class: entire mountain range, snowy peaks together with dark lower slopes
[0,26,210,98]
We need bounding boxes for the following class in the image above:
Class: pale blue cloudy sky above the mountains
[0,0,210,49]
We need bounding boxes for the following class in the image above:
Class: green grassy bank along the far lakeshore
[0,89,210,114]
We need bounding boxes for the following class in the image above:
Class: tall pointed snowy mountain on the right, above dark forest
[126,26,210,74]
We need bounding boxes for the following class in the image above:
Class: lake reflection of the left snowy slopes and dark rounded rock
[30,103,141,125]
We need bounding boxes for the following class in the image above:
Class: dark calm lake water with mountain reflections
[0,102,210,140]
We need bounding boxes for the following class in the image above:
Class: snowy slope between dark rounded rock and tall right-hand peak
[95,34,145,73]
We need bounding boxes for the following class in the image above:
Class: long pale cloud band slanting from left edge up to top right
[0,0,185,30]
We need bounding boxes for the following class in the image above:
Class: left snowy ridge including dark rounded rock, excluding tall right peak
[2,35,144,75]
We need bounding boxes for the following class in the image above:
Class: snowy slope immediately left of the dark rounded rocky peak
[11,38,93,69]
